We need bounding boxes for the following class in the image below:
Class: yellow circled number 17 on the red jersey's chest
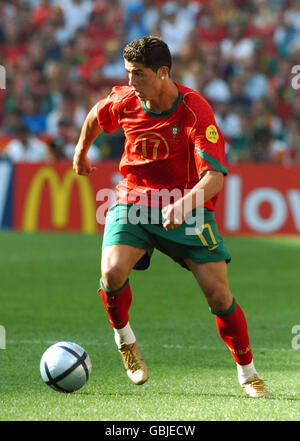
[134,132,169,161]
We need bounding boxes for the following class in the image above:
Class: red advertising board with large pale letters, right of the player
[216,164,300,234]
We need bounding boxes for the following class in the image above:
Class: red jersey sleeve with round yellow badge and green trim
[194,98,227,178]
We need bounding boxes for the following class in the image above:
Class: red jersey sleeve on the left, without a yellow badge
[97,88,120,133]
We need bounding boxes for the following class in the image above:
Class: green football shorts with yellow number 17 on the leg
[102,203,231,270]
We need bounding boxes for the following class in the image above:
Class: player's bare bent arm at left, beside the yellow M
[73,104,103,176]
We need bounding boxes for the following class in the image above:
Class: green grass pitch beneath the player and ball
[0,232,300,421]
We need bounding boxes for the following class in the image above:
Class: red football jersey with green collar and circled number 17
[97,83,227,210]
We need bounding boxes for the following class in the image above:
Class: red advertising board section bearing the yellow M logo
[13,162,117,233]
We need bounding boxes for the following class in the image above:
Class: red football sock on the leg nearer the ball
[99,280,132,329]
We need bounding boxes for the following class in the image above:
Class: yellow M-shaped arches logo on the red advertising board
[23,167,97,233]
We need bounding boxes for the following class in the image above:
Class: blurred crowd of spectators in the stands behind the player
[0,0,300,165]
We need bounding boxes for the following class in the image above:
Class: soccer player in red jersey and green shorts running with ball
[73,36,269,397]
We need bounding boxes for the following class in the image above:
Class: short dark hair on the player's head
[123,35,172,72]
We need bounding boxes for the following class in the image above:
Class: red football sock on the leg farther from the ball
[214,300,253,365]
